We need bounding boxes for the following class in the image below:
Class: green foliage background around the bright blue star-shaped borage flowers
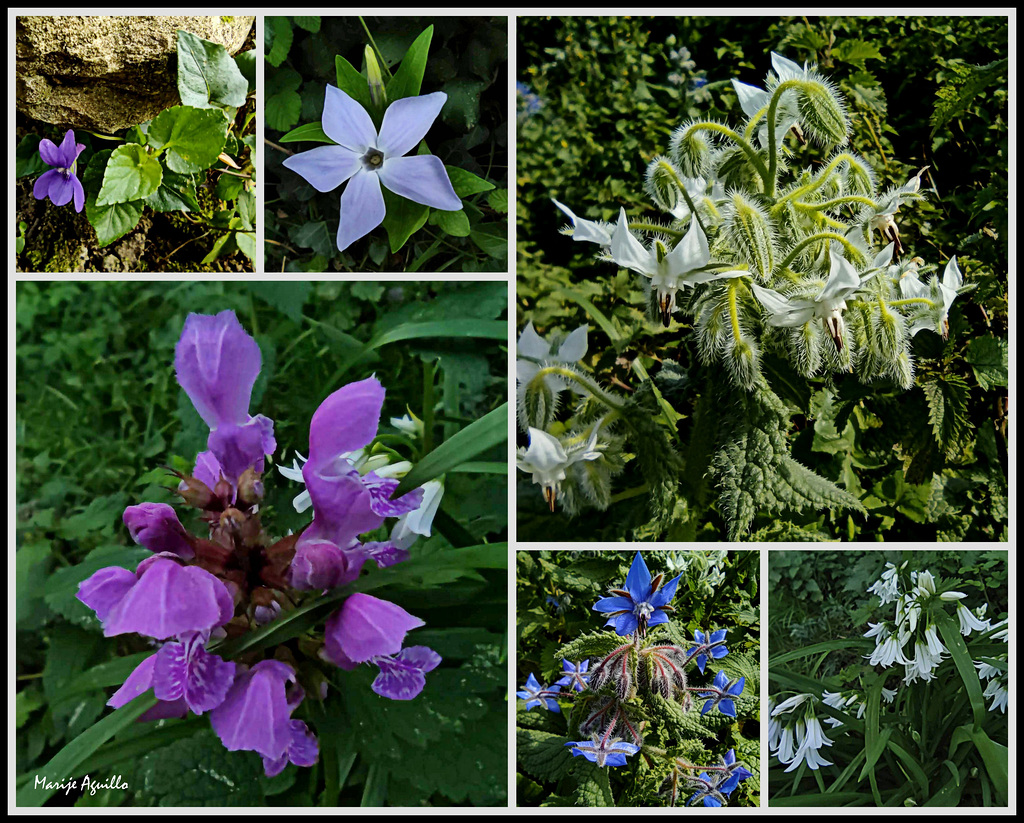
[516,550,761,807]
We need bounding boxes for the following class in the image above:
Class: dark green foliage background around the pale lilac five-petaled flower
[265,16,508,271]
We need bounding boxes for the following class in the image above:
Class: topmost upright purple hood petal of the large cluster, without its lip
[174,309,261,429]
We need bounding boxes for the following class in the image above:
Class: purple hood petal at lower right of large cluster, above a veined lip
[327,594,425,663]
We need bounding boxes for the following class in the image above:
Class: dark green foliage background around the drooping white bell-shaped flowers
[768,550,1010,806]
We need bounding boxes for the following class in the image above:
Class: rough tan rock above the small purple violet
[15,16,255,132]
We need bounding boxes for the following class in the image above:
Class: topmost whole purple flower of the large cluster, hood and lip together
[174,310,278,488]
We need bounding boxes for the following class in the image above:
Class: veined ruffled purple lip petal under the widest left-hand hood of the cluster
[153,635,234,714]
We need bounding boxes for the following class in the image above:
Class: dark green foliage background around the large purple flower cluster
[14,281,507,806]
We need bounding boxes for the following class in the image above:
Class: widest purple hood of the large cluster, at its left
[76,554,234,640]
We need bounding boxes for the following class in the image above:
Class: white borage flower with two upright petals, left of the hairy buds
[611,209,750,327]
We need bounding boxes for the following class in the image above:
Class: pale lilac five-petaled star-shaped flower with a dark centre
[284,86,462,252]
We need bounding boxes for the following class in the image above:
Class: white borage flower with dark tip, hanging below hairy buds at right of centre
[753,242,892,351]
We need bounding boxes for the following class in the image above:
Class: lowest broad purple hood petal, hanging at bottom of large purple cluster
[210,660,294,761]
